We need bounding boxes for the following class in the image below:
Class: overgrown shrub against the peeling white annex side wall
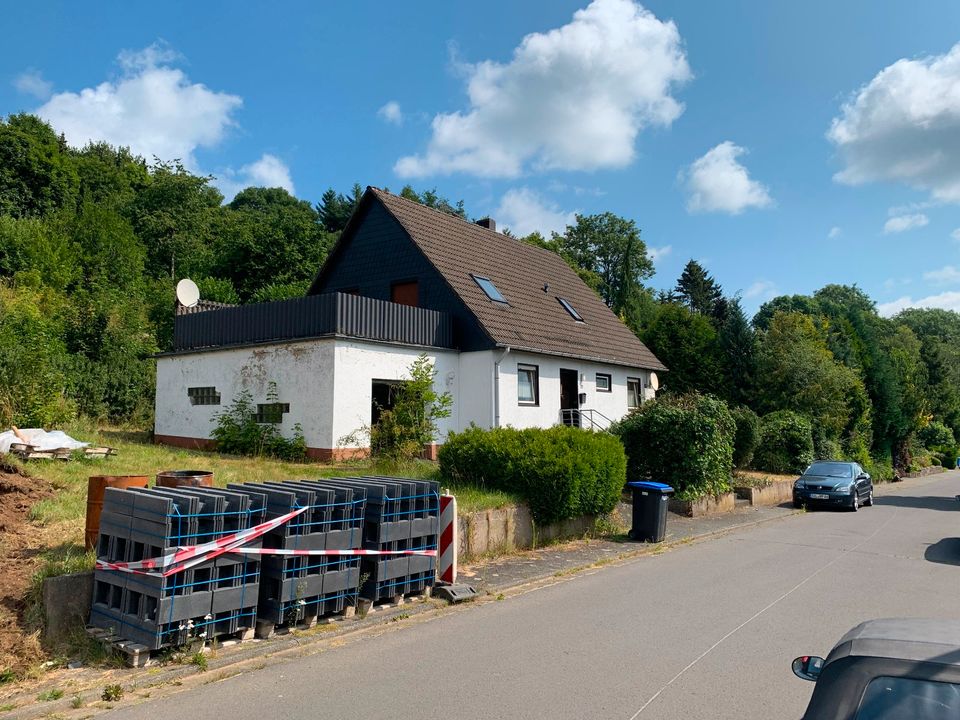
[210,389,307,460]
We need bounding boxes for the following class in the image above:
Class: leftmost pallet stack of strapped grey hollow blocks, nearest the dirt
[90,488,264,650]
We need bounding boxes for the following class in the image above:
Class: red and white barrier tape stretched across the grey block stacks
[97,506,442,577]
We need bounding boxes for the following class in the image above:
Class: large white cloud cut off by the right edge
[827,44,960,202]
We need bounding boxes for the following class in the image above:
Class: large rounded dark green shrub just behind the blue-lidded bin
[614,393,736,500]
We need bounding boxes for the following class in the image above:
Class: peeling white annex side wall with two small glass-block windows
[154,338,336,447]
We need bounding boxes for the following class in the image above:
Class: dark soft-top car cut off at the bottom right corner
[793,618,960,720]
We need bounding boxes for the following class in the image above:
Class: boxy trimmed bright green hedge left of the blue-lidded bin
[439,426,627,524]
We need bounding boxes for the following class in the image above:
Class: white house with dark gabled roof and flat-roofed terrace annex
[155,188,666,459]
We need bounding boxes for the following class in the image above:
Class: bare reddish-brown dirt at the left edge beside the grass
[0,463,52,673]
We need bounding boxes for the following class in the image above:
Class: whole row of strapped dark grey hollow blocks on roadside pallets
[90,477,439,650]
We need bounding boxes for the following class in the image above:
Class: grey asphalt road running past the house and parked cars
[112,472,960,720]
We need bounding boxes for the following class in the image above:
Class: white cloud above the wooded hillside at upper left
[36,45,243,171]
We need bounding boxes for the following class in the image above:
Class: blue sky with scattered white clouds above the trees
[0,0,960,313]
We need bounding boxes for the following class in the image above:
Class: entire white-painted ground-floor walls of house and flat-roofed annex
[155,338,649,449]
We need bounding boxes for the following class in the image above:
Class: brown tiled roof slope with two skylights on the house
[368,188,666,370]
